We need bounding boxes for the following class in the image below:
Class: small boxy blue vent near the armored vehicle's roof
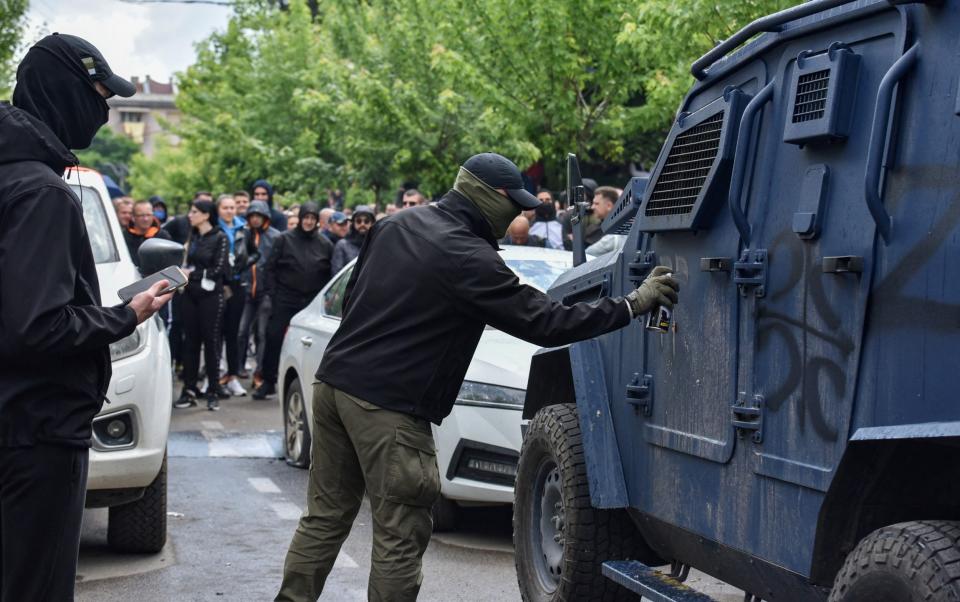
[783,43,860,145]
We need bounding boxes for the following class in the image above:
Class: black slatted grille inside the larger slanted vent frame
[645,111,724,216]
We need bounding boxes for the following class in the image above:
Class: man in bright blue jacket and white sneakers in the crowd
[217,194,247,397]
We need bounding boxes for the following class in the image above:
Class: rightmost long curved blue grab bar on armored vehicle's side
[864,42,920,243]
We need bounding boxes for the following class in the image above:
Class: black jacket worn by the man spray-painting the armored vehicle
[316,191,630,424]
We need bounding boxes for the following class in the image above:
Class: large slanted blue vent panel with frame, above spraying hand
[636,88,749,232]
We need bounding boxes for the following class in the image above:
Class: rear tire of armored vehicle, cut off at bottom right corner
[830,521,960,602]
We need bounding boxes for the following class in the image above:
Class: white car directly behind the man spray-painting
[279,246,572,530]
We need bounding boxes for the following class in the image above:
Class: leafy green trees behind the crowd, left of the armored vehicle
[131,0,798,204]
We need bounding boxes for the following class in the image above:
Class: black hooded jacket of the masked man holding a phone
[0,103,137,447]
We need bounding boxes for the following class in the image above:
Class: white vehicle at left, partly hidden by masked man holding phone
[64,168,173,552]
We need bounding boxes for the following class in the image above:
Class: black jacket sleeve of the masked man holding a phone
[0,186,137,359]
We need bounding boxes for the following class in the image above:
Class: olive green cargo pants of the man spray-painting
[276,383,440,602]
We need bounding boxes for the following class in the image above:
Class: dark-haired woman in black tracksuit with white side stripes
[174,201,230,410]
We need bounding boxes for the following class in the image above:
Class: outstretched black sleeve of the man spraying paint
[449,247,630,347]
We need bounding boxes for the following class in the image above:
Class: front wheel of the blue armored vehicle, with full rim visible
[513,404,654,602]
